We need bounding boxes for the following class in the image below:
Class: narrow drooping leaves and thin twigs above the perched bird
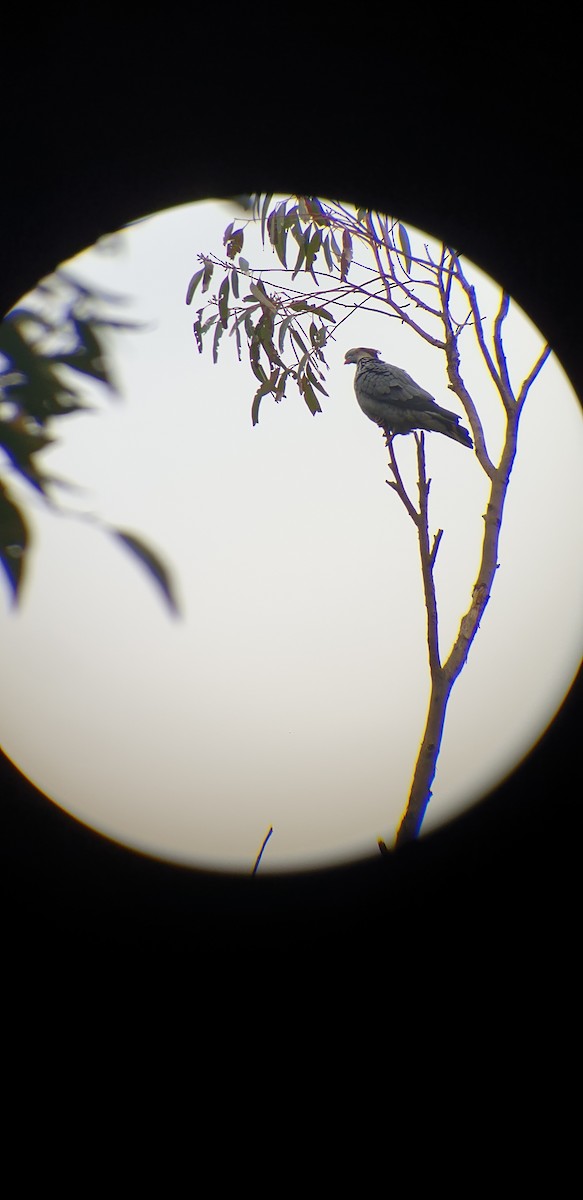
[186,196,494,434]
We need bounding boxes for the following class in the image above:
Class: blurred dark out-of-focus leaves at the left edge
[0,271,175,611]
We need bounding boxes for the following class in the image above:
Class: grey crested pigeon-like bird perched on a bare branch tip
[344,346,474,450]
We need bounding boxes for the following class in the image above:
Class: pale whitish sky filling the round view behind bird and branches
[0,202,583,871]
